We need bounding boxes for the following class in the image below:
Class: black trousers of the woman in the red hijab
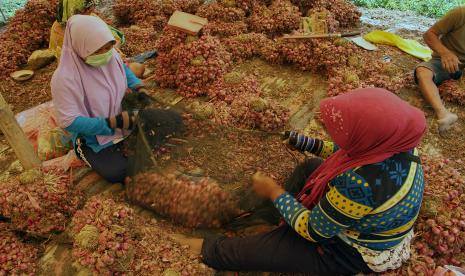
[202,159,372,275]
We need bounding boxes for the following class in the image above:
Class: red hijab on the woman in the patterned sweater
[298,88,426,208]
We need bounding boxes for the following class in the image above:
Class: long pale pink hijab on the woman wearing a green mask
[51,15,127,145]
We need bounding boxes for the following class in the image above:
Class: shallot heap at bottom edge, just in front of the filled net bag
[71,197,213,275]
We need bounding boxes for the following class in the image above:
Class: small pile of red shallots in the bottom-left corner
[0,222,39,275]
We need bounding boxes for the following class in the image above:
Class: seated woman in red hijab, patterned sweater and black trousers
[171,88,426,275]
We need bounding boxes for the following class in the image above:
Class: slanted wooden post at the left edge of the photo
[0,90,41,170]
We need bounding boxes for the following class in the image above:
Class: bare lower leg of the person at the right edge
[415,59,460,133]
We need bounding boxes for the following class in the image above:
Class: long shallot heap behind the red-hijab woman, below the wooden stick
[262,39,408,96]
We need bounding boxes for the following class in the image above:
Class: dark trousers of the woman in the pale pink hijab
[76,143,128,183]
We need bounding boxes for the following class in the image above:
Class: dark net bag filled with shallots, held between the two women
[126,109,238,228]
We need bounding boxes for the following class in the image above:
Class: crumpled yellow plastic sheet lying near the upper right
[363,30,433,61]
